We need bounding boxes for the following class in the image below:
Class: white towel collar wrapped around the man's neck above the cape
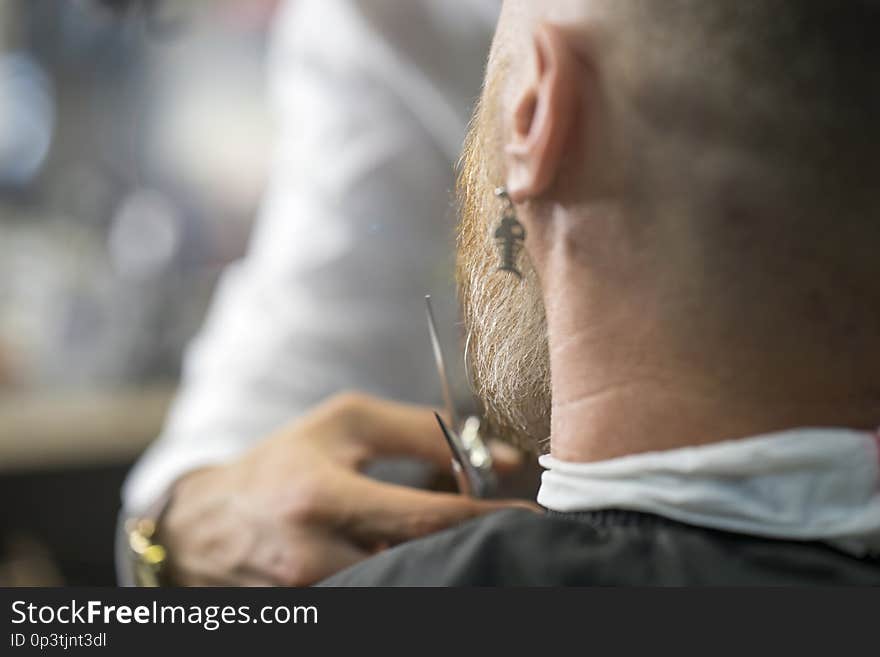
[538,429,880,555]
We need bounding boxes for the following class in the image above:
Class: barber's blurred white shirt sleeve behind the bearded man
[123,0,498,513]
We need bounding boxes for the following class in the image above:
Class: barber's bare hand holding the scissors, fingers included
[159,394,533,586]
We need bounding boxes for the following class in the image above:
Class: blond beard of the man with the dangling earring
[456,79,550,452]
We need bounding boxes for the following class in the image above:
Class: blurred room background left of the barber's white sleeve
[0,0,276,585]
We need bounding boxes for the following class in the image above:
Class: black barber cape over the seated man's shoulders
[321,509,880,586]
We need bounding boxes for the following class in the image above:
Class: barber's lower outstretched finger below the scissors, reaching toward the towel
[340,480,538,544]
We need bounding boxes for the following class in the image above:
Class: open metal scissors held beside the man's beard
[425,295,497,497]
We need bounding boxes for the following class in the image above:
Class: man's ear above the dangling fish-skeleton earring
[504,23,583,202]
